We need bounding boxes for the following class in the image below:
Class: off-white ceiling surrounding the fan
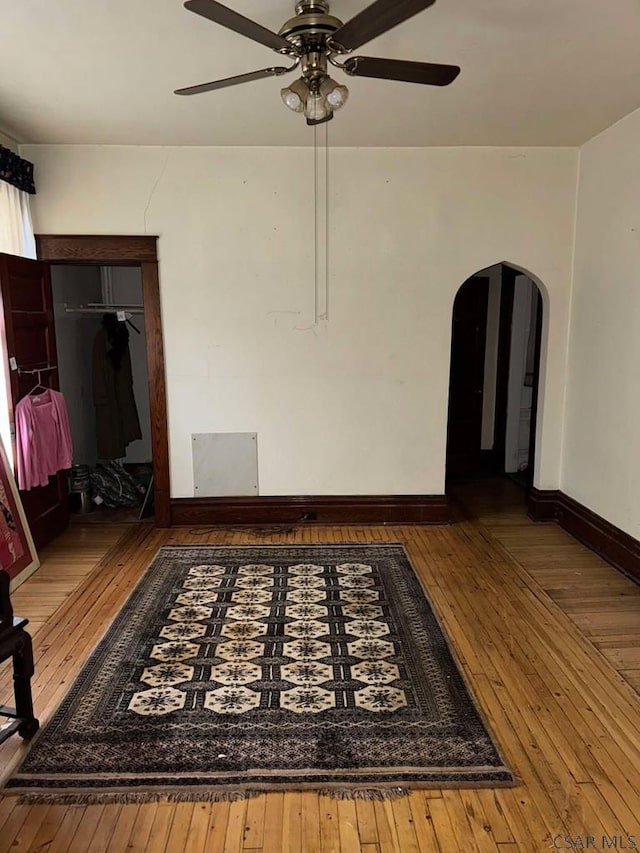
[0,0,640,146]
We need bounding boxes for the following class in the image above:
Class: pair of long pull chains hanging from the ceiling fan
[313,123,329,325]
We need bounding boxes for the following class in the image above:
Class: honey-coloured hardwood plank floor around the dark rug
[0,484,640,853]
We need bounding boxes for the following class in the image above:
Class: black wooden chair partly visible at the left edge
[0,570,40,743]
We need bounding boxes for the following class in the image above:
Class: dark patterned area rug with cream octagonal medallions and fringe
[4,545,514,802]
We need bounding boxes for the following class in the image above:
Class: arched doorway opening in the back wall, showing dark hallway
[446,263,543,486]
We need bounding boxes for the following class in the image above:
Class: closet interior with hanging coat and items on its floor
[51,263,154,523]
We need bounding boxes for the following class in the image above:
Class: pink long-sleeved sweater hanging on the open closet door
[16,389,73,491]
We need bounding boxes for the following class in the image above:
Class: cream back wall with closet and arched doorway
[22,146,577,497]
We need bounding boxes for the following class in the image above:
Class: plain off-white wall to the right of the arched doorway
[561,105,640,537]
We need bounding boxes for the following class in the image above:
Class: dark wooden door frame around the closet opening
[36,234,171,527]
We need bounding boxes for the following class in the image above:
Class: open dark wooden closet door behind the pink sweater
[0,254,69,548]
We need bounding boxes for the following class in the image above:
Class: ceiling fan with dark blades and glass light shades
[175,0,460,125]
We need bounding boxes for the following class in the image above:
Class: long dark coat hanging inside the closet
[93,314,142,459]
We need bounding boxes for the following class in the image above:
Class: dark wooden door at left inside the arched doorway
[447,276,489,478]
